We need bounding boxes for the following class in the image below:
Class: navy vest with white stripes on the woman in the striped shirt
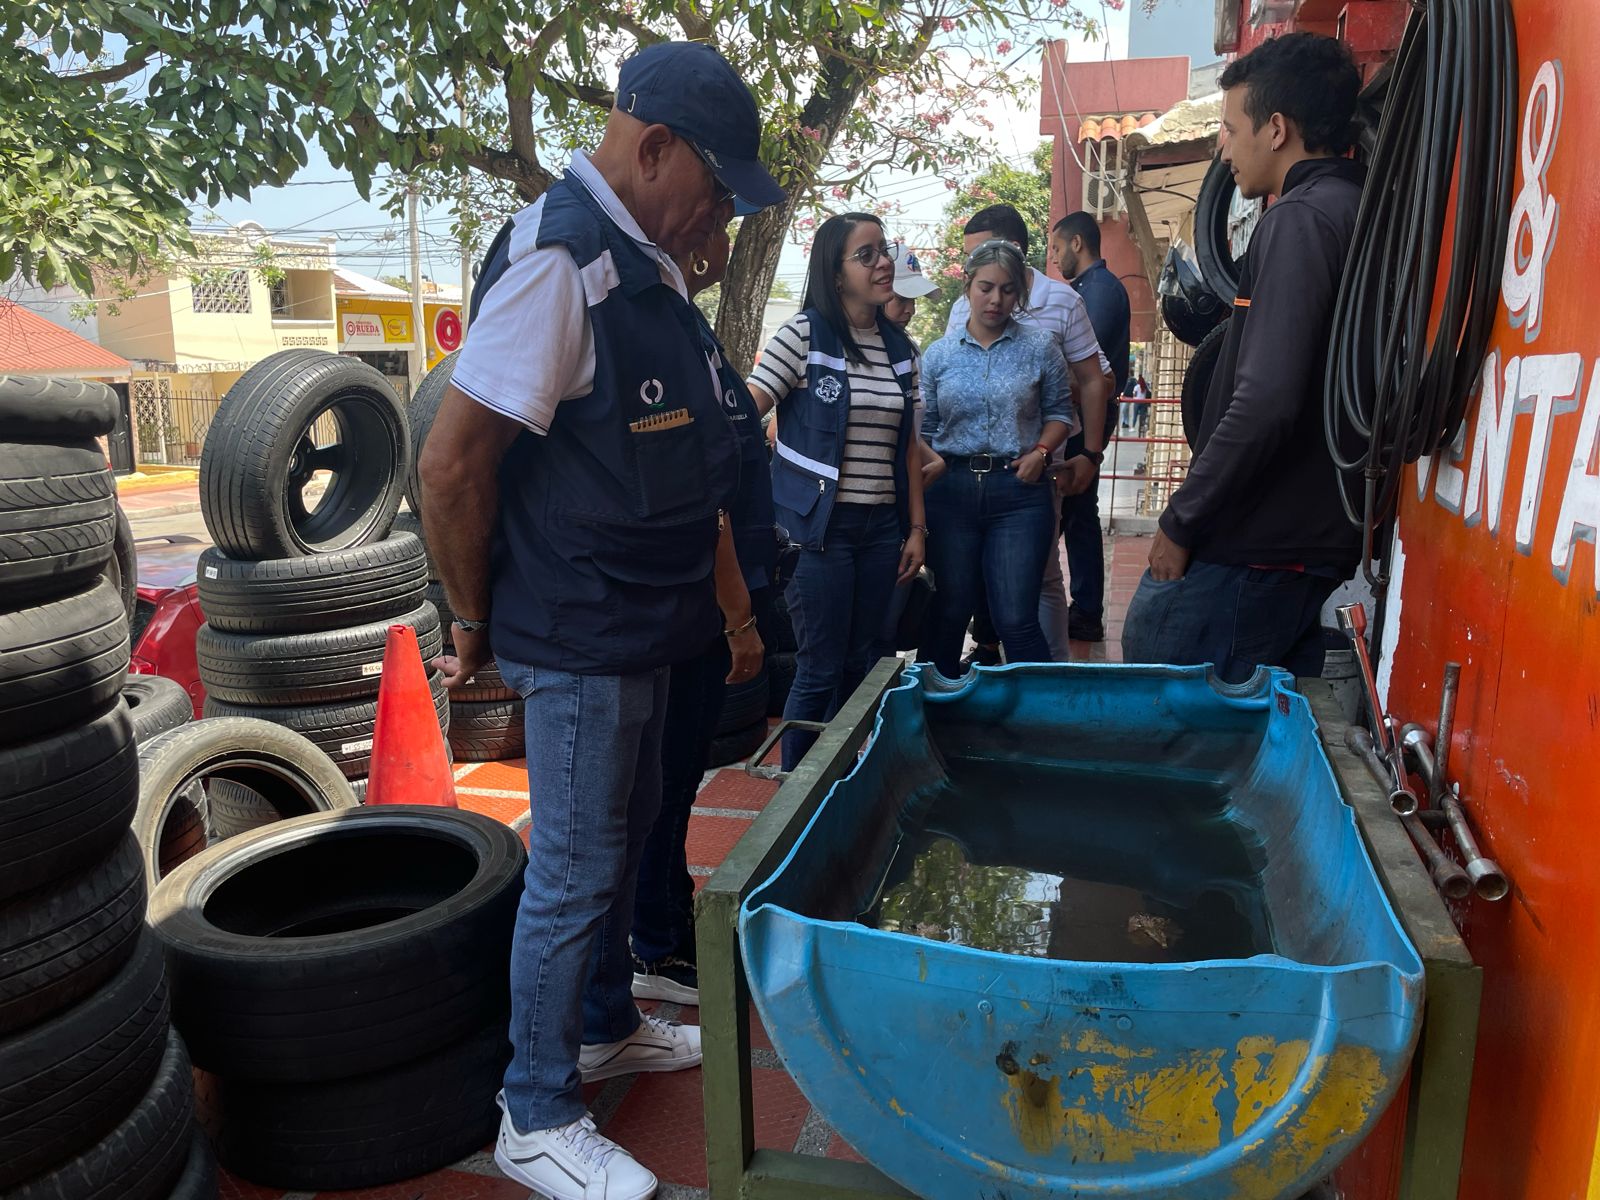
[773,309,917,550]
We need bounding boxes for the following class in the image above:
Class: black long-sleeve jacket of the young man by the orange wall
[1162,158,1365,570]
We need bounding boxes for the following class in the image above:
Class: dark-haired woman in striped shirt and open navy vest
[749,213,928,770]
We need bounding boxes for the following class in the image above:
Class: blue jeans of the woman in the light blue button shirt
[923,466,1056,678]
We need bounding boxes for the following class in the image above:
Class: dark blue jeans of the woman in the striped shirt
[784,504,901,771]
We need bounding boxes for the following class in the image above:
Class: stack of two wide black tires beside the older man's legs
[150,803,526,1192]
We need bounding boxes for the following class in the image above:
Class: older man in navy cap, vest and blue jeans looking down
[421,42,782,1200]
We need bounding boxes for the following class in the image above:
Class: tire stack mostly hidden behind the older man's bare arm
[395,350,525,763]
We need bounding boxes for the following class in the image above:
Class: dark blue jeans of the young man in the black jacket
[1122,562,1339,683]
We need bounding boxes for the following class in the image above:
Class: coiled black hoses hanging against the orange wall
[1323,0,1518,587]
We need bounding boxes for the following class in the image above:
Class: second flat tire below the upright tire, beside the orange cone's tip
[195,600,443,704]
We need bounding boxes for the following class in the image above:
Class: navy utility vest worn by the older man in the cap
[478,173,739,675]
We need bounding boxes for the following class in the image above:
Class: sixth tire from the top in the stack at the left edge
[0,936,166,1189]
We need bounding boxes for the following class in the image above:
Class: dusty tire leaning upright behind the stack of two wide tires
[133,717,355,888]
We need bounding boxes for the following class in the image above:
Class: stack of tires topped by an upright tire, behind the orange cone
[195,350,450,812]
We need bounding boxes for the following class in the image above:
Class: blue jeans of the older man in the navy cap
[499,659,667,1133]
